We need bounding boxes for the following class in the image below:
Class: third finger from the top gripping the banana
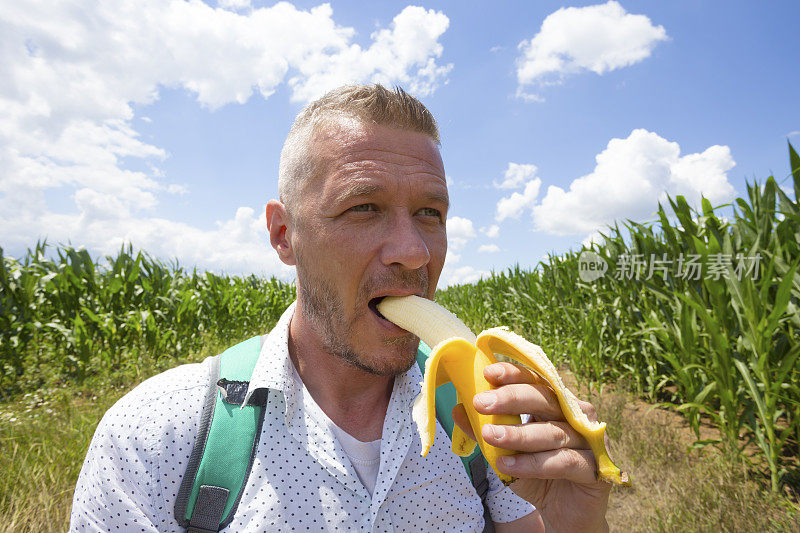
[481,422,589,452]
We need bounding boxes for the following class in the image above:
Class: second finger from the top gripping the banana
[472,384,564,420]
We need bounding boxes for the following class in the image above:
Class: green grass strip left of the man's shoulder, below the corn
[0,339,224,533]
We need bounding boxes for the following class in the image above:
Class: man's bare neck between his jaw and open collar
[289,311,394,442]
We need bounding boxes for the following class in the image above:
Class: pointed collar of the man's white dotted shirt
[242,301,422,407]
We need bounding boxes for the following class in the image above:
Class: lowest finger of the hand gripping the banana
[497,448,597,483]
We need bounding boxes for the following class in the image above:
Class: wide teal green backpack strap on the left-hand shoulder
[174,337,266,533]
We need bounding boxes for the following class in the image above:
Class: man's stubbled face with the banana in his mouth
[291,121,448,375]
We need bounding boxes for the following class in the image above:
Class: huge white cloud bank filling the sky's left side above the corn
[0,4,452,273]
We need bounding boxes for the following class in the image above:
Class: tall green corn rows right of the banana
[437,145,800,491]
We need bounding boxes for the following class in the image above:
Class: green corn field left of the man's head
[0,244,295,398]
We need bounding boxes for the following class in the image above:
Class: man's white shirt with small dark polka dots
[70,304,534,533]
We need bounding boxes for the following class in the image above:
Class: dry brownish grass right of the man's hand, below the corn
[576,372,800,533]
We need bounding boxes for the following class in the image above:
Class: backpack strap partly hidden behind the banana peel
[417,341,494,533]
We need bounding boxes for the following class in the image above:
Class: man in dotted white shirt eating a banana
[71,85,609,533]
